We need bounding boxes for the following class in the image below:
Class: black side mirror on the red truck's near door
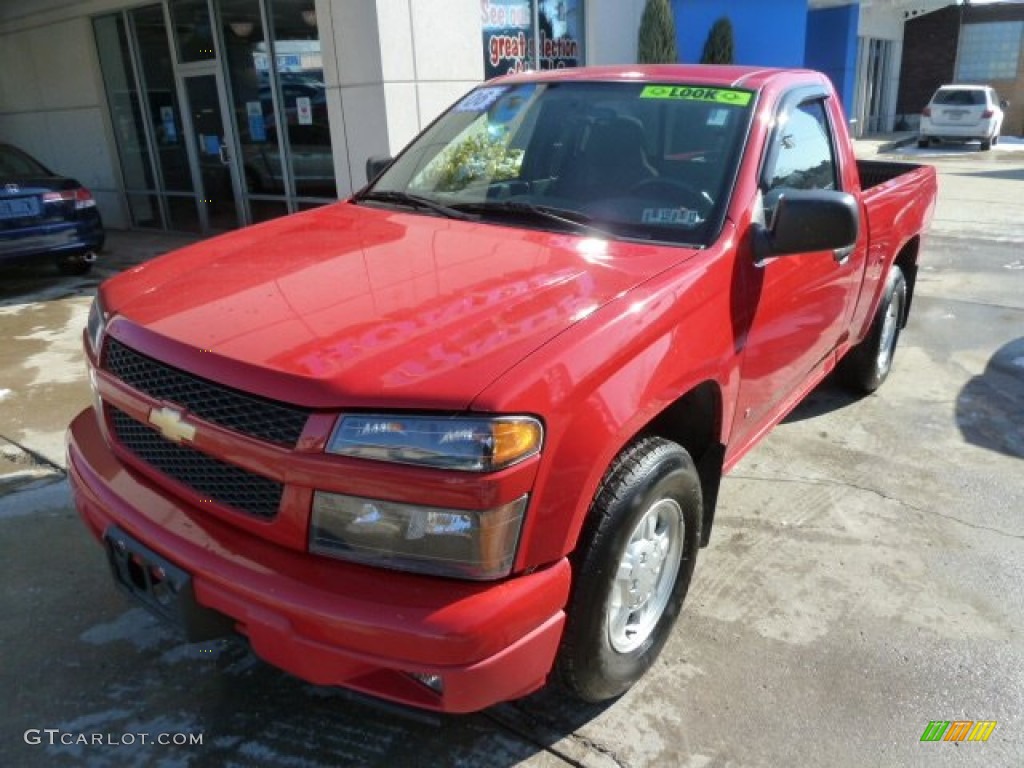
[755,189,860,262]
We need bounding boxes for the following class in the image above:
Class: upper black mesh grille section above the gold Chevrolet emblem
[103,339,309,447]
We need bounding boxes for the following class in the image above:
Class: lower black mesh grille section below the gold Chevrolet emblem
[108,406,284,519]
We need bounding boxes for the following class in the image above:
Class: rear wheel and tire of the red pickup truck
[838,264,906,393]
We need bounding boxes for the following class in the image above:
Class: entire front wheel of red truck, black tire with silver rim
[556,437,701,702]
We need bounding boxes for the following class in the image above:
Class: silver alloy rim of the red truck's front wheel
[608,499,683,653]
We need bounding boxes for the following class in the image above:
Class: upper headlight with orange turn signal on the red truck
[327,414,544,472]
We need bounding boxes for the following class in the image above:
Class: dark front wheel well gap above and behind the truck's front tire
[642,381,725,547]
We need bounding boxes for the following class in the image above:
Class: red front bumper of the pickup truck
[68,409,570,712]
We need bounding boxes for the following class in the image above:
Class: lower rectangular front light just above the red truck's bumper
[309,490,527,580]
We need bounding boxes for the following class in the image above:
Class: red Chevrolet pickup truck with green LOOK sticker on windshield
[68,67,936,712]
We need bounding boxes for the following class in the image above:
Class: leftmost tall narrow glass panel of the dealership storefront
[93,13,159,192]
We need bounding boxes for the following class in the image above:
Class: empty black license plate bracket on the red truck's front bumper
[103,525,234,643]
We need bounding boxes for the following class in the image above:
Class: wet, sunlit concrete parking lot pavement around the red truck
[0,143,1024,768]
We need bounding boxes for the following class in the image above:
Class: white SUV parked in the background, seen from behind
[918,85,1007,151]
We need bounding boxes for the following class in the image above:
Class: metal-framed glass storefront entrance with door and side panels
[93,0,337,233]
